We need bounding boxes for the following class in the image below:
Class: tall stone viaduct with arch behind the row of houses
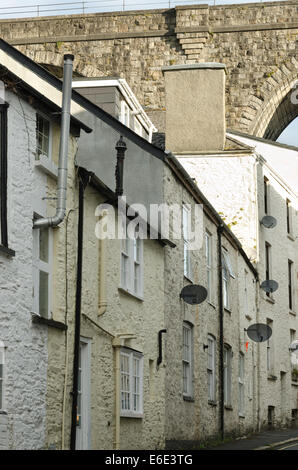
[0,0,298,140]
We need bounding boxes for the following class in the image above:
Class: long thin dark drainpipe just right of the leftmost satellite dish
[217,225,225,440]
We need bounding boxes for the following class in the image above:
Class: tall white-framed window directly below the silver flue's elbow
[32,221,53,318]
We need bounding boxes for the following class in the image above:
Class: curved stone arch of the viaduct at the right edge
[240,57,298,140]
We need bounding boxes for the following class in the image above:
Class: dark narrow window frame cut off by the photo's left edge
[0,104,8,247]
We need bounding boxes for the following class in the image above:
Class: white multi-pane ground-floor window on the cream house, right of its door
[120,347,144,418]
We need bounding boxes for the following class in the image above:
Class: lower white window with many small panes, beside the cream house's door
[119,347,144,418]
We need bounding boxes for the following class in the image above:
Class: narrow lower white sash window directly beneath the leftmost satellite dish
[182,322,194,399]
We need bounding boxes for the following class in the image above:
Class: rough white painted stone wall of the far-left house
[0,92,47,449]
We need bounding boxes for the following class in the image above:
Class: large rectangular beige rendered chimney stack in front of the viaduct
[162,62,226,154]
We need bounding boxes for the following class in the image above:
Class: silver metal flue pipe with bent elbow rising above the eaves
[33,54,74,228]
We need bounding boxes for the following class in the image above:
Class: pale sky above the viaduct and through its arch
[0,0,298,147]
